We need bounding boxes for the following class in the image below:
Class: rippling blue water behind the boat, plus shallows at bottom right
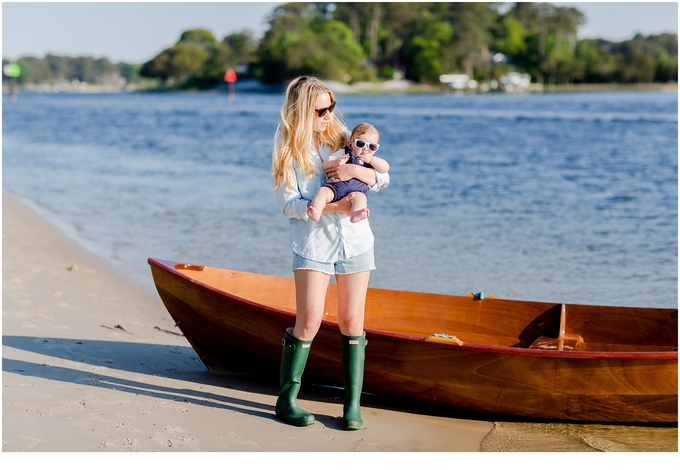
[2,92,678,452]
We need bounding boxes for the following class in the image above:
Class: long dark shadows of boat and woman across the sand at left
[2,336,526,429]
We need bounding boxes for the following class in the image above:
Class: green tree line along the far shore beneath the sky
[2,2,678,88]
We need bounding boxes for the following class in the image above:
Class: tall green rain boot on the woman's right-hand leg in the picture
[341,333,368,431]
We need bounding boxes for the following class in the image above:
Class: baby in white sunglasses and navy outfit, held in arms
[307,122,390,223]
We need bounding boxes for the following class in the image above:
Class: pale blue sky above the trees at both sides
[2,1,678,63]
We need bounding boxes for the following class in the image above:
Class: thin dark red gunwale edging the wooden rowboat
[147,258,678,361]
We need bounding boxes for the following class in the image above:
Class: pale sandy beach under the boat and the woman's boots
[2,195,677,458]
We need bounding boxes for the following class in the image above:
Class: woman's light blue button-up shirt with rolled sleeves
[275,145,390,263]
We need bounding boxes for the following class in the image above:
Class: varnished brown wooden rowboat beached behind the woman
[149,259,678,423]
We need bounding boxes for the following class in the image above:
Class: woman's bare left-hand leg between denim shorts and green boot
[293,269,331,340]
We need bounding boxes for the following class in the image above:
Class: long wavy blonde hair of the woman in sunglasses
[272,76,349,189]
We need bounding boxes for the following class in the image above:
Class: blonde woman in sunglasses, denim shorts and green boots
[272,76,389,430]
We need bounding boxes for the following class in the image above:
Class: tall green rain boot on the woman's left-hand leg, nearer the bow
[276,328,314,426]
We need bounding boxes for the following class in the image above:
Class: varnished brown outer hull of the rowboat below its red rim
[149,259,678,423]
